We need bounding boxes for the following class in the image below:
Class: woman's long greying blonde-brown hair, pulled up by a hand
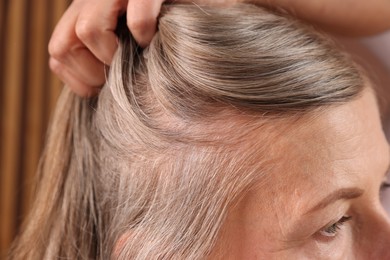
[11,5,364,259]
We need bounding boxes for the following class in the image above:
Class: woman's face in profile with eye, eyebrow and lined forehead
[217,90,390,259]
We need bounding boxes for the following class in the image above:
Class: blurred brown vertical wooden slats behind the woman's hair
[0,0,71,259]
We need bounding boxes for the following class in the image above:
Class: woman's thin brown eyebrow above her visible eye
[304,188,364,215]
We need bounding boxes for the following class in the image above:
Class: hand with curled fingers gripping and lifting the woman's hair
[49,0,164,96]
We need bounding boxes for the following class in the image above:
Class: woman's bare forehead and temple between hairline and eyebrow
[235,91,389,234]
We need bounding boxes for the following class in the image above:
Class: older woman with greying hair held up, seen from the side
[11,0,390,259]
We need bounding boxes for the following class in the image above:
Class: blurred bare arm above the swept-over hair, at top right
[250,0,390,37]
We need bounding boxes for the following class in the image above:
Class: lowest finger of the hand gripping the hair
[49,58,100,97]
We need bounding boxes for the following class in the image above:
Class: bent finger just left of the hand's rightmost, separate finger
[76,0,127,64]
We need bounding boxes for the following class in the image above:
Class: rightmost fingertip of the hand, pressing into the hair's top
[127,0,164,47]
